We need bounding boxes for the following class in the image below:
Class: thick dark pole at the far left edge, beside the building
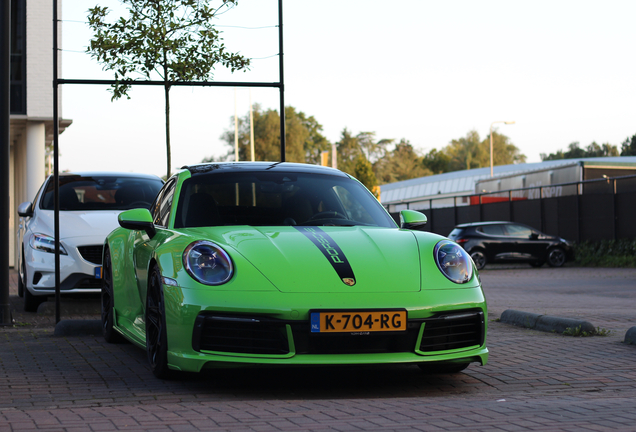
[0,1,13,325]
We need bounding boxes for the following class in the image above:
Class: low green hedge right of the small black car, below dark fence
[574,239,636,268]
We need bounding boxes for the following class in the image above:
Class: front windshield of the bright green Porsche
[175,172,396,228]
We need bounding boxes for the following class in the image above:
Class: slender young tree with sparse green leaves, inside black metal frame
[86,0,250,177]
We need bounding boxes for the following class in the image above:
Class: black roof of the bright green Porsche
[181,161,349,177]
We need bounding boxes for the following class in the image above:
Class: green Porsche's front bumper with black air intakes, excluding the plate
[153,285,488,372]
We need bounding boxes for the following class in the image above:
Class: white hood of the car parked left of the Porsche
[29,209,121,243]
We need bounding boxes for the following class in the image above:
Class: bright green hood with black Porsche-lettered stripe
[212,226,420,293]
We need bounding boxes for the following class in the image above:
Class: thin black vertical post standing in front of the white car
[53,0,60,324]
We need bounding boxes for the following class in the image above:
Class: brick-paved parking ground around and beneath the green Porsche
[0,266,636,431]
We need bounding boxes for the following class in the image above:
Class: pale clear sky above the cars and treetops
[60,0,636,176]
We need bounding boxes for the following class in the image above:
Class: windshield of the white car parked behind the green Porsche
[40,175,163,211]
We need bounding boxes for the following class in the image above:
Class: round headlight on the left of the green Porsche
[183,240,234,285]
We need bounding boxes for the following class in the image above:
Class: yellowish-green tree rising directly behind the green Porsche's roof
[221,104,331,164]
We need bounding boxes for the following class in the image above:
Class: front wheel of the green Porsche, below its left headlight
[146,265,172,379]
